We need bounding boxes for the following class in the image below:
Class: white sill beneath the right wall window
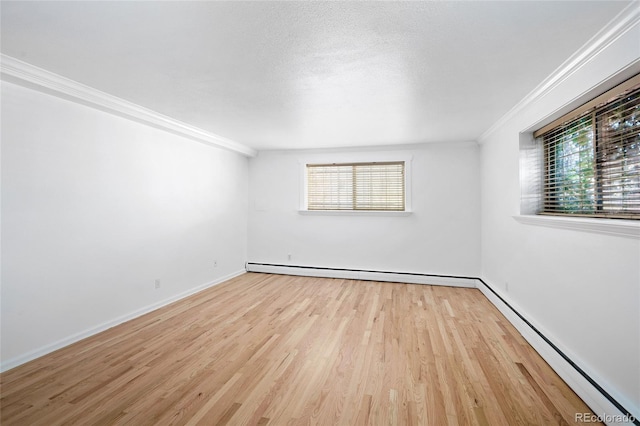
[513,215,640,239]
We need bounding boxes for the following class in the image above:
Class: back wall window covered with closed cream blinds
[306,161,405,211]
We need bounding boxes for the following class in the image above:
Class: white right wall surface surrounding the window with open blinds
[481,20,640,416]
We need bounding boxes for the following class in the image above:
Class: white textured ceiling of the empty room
[0,1,630,149]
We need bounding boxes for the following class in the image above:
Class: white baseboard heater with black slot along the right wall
[478,279,640,425]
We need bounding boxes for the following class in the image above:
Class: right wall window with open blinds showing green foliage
[534,75,640,219]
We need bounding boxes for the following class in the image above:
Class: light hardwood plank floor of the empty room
[0,273,590,426]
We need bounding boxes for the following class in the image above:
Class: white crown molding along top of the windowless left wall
[0,54,257,157]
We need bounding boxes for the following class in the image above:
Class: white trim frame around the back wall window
[298,153,413,216]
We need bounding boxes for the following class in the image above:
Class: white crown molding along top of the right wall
[478,0,640,144]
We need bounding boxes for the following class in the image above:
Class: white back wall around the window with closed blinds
[249,143,480,276]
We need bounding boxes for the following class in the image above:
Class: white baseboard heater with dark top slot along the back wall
[246,262,479,288]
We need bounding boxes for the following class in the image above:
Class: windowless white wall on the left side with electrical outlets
[1,82,248,366]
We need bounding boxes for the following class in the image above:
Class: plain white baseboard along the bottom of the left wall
[0,270,246,372]
